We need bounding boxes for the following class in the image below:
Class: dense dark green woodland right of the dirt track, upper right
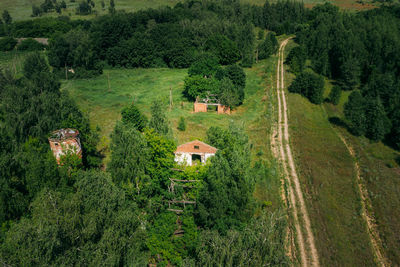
[296,4,400,148]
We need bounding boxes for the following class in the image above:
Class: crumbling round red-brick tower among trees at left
[49,128,82,164]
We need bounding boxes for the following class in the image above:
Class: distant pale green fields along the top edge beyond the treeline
[0,0,375,20]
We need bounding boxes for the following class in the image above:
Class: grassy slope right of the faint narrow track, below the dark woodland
[324,89,400,266]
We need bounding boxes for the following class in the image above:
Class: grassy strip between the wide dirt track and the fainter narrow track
[286,40,374,266]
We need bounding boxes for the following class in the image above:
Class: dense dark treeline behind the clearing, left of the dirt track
[0,0,306,77]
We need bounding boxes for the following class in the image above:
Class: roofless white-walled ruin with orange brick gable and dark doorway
[175,140,217,166]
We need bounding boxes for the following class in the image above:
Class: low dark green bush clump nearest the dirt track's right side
[288,72,325,105]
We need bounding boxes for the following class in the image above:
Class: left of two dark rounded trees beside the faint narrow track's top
[344,91,367,138]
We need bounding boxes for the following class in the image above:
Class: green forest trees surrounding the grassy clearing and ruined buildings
[0,0,400,266]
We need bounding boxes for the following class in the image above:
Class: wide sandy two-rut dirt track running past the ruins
[271,38,319,266]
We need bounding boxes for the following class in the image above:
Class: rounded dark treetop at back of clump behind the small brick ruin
[188,54,220,78]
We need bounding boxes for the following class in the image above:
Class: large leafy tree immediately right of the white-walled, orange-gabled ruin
[195,127,253,234]
